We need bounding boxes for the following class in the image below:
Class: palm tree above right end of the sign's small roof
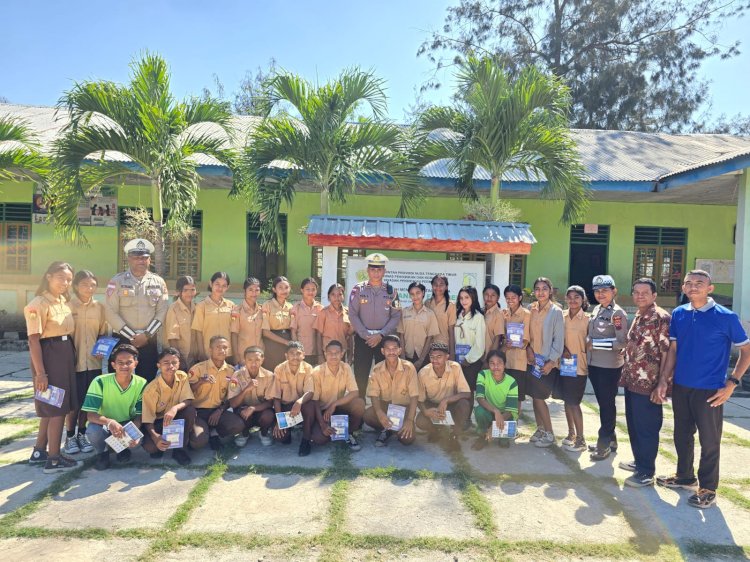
[419,56,588,224]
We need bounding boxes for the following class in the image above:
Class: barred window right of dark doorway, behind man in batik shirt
[633,226,687,293]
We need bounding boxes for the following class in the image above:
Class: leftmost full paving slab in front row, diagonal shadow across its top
[22,467,202,530]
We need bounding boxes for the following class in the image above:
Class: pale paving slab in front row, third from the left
[345,478,482,539]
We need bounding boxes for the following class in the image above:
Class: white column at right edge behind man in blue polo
[732,168,750,330]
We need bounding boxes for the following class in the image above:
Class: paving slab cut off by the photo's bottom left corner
[0,538,148,562]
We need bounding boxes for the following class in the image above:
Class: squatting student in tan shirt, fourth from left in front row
[227,347,276,447]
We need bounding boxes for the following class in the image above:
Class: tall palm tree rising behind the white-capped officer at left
[51,53,241,274]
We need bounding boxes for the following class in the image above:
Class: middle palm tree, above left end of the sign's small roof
[245,68,423,250]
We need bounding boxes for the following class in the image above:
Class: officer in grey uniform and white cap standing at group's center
[349,254,401,389]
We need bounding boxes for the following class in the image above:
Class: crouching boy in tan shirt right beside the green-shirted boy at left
[141,347,196,466]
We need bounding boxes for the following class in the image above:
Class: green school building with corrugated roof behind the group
[0,104,750,321]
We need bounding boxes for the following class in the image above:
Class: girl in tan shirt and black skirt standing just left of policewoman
[558,285,589,452]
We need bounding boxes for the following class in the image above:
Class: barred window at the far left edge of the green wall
[0,203,32,273]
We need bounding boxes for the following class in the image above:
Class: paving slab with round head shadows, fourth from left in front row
[488,482,635,543]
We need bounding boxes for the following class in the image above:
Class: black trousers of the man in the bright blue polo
[672,384,724,491]
